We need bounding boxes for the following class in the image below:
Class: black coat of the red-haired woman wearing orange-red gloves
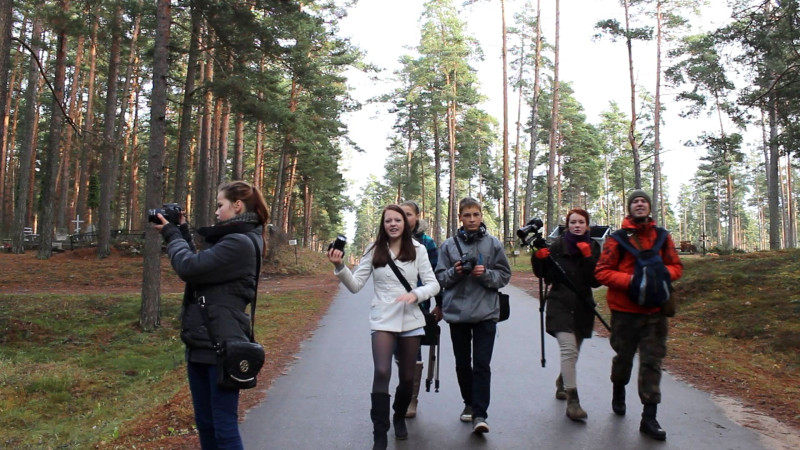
[531,237,601,339]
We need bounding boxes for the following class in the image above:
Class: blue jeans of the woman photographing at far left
[186,362,244,450]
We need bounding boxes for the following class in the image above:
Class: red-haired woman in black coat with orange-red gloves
[531,208,601,420]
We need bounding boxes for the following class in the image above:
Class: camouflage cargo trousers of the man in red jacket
[611,311,667,404]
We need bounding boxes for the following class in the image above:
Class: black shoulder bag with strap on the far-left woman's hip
[198,235,265,390]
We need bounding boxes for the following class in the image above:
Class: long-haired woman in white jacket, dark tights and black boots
[328,205,439,449]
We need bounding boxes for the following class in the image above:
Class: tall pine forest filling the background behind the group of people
[0,0,800,284]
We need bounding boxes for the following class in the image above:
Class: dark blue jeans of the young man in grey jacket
[450,320,497,419]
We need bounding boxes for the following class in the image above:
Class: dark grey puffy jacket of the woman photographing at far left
[162,223,264,364]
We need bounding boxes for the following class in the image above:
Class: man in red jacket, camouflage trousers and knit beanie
[595,189,683,441]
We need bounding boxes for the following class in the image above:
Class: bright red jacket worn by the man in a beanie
[594,217,683,314]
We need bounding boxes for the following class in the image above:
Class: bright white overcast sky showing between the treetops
[334,0,728,235]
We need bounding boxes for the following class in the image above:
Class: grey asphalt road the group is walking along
[241,275,765,450]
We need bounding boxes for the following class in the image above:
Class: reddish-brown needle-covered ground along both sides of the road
[0,249,800,449]
